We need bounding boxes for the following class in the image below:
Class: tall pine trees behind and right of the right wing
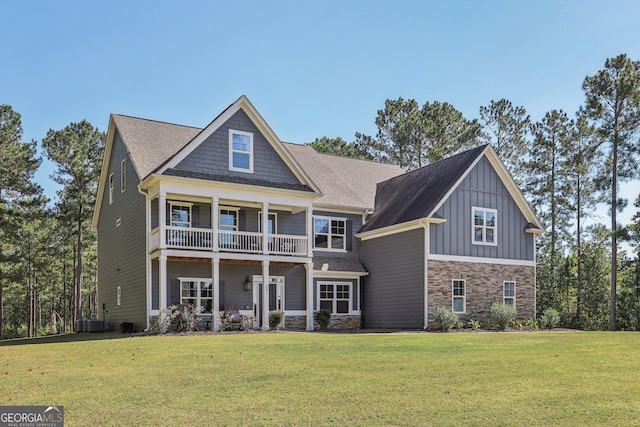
[307,54,640,330]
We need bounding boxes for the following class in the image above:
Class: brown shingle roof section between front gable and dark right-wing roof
[285,143,404,210]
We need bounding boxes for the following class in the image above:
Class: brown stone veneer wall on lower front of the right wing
[428,260,536,327]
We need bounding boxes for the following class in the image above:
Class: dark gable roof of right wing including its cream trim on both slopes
[359,144,543,234]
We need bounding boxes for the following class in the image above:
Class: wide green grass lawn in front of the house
[0,332,640,426]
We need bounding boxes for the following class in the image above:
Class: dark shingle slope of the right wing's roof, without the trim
[360,145,487,232]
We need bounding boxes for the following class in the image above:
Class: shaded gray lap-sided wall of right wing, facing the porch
[360,229,425,328]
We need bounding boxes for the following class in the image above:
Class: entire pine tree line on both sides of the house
[0,55,640,339]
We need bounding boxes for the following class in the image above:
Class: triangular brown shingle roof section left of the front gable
[112,114,202,179]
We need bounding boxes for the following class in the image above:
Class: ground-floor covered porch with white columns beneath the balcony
[148,255,313,331]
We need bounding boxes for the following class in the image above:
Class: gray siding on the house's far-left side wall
[98,132,147,331]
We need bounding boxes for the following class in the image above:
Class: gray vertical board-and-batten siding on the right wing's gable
[429,157,534,260]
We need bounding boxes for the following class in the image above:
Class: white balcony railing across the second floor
[149,226,308,256]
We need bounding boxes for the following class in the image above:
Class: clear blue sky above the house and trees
[0,0,640,231]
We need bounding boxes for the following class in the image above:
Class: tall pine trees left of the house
[0,105,105,339]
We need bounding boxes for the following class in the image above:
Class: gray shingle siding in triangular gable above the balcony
[176,110,300,184]
